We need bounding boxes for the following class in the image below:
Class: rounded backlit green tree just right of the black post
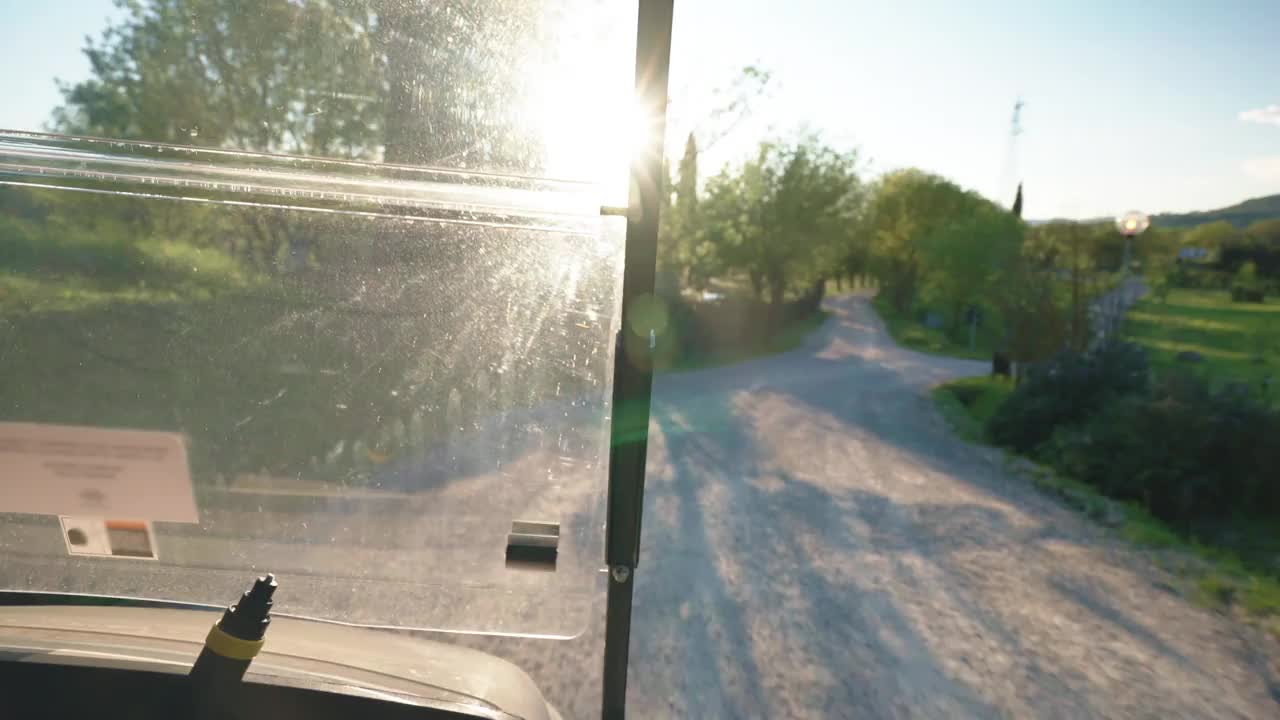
[699,136,863,315]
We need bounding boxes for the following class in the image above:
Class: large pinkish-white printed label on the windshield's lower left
[0,423,200,523]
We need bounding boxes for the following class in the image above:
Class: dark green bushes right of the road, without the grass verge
[987,343,1280,528]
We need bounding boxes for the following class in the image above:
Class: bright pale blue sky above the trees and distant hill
[0,0,1280,219]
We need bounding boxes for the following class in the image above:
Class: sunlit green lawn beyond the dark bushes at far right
[1125,290,1280,398]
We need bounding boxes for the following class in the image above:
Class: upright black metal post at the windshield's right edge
[602,0,675,720]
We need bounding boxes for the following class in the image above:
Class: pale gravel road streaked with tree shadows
[467,297,1280,719]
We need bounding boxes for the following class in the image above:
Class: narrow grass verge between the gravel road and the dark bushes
[932,377,1280,637]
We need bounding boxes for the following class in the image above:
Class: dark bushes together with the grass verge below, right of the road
[934,342,1280,630]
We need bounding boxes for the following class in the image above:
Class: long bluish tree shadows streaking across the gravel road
[632,295,1259,716]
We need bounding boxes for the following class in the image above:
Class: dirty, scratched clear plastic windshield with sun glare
[0,0,635,637]
